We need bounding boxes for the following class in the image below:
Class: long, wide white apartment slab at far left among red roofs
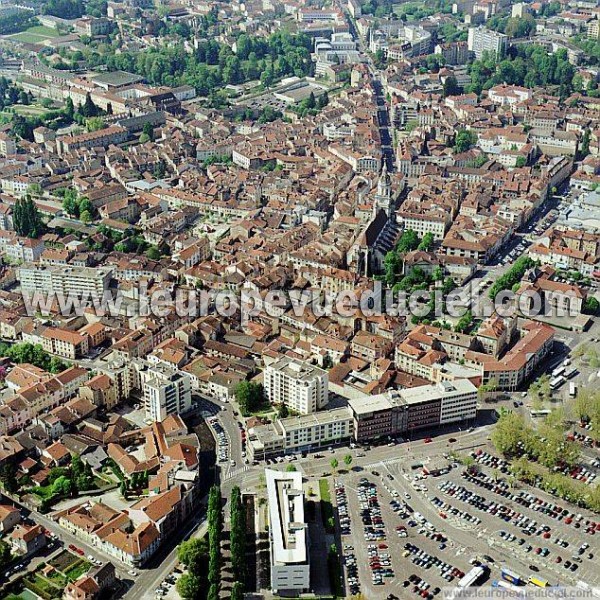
[18,264,112,298]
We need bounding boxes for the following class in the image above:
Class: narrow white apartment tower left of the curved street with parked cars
[140,365,192,421]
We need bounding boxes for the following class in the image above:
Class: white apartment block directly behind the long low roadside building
[264,357,329,415]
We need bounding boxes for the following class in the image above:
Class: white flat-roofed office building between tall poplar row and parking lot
[265,469,310,595]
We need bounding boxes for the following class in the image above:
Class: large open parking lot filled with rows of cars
[336,447,600,600]
